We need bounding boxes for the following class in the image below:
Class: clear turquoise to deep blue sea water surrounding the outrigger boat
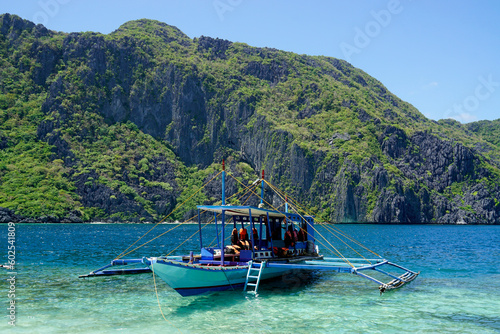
[0,224,500,333]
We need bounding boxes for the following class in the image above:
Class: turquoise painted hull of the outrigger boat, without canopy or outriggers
[147,258,292,296]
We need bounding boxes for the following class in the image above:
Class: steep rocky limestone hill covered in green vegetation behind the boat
[0,14,500,224]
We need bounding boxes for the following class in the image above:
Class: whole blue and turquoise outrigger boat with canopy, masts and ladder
[80,162,419,296]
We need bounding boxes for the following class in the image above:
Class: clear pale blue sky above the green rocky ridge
[0,0,500,123]
